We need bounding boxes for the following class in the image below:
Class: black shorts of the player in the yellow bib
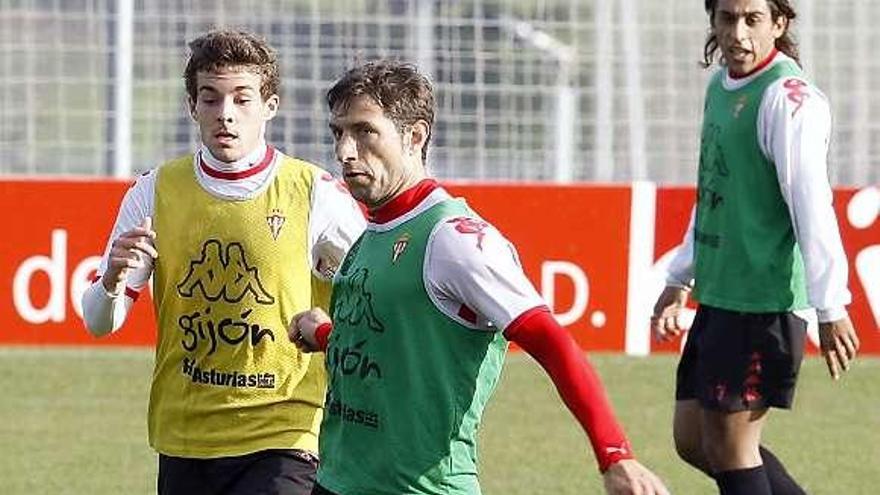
[157,449,318,495]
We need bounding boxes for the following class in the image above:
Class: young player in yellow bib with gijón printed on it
[83,31,364,494]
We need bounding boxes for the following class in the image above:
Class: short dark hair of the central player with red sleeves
[327,60,434,162]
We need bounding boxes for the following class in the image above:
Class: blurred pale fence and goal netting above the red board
[0,0,880,185]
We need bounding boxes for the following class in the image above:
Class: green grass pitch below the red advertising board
[0,348,880,495]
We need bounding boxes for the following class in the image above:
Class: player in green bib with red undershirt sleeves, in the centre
[290,61,667,495]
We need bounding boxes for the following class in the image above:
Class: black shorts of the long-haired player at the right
[675,305,807,412]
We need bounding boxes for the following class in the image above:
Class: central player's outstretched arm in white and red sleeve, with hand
[424,218,666,493]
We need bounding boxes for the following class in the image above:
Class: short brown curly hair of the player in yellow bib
[183,29,281,101]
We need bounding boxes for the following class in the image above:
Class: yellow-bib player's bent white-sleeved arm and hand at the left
[82,172,158,336]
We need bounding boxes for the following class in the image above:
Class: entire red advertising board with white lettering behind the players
[0,180,880,354]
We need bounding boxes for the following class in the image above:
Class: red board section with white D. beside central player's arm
[449,185,631,351]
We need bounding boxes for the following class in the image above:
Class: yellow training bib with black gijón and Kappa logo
[149,153,327,458]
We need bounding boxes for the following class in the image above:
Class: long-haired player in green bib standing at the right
[652,0,859,495]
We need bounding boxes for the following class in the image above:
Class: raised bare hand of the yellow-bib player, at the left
[101,217,159,295]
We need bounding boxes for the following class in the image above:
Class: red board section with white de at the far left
[0,180,156,345]
